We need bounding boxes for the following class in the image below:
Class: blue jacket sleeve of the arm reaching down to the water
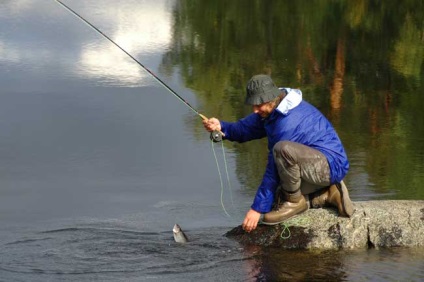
[251,152,280,213]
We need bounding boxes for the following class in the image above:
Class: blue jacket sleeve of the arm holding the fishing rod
[221,114,266,143]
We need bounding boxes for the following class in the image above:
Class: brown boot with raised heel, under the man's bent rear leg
[311,181,353,217]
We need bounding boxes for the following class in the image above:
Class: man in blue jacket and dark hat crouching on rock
[203,74,353,232]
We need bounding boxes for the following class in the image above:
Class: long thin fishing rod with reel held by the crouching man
[55,0,225,142]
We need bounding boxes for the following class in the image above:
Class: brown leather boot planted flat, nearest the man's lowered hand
[262,189,308,225]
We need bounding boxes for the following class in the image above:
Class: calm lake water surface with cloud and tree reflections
[0,0,424,281]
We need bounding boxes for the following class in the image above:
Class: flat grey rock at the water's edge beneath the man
[225,200,424,250]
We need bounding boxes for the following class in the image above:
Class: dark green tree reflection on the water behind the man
[161,0,424,199]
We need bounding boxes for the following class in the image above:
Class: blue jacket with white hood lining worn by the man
[221,88,349,213]
